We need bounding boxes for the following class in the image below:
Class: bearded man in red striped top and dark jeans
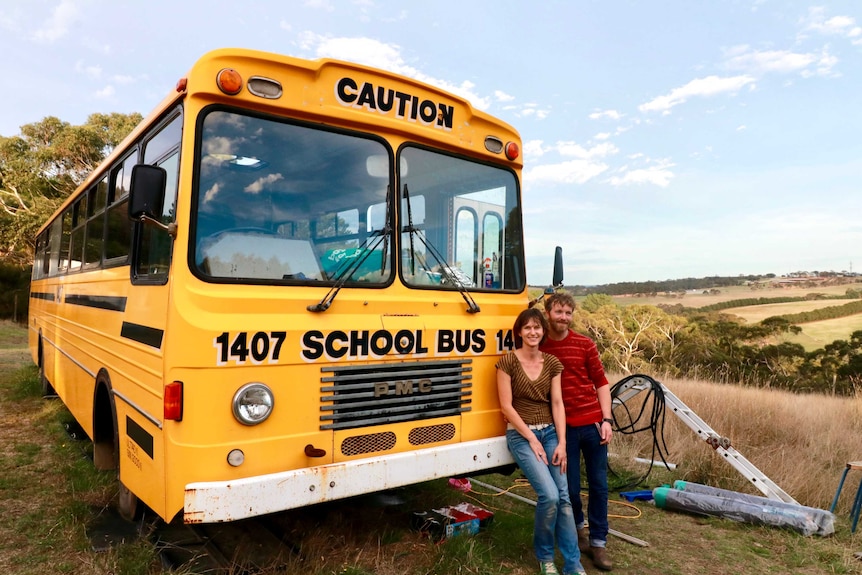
[540,292,613,571]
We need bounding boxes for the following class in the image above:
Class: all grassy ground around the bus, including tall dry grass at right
[0,323,862,575]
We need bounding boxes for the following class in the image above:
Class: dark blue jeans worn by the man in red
[566,424,608,547]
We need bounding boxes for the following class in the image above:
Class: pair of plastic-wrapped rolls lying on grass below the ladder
[653,483,835,536]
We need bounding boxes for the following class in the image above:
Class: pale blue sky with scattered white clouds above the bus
[0,0,862,285]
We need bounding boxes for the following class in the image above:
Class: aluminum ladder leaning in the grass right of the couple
[613,375,799,505]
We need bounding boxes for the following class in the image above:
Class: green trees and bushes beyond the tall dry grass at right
[573,294,862,396]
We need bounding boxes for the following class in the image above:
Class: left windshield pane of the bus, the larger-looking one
[192,110,391,285]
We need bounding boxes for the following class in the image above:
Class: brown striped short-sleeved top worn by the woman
[497,351,563,425]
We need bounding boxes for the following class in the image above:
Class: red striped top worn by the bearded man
[539,329,608,427]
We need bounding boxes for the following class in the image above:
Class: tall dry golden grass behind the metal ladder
[614,379,862,513]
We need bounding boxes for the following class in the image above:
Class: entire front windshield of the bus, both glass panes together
[190,108,524,291]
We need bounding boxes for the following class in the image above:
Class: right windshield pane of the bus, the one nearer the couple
[398,146,524,290]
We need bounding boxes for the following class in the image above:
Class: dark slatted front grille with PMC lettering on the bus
[320,359,472,429]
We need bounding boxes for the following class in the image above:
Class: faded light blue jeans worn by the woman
[506,425,583,573]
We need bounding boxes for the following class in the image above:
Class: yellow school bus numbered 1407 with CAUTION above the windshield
[29,49,528,523]
